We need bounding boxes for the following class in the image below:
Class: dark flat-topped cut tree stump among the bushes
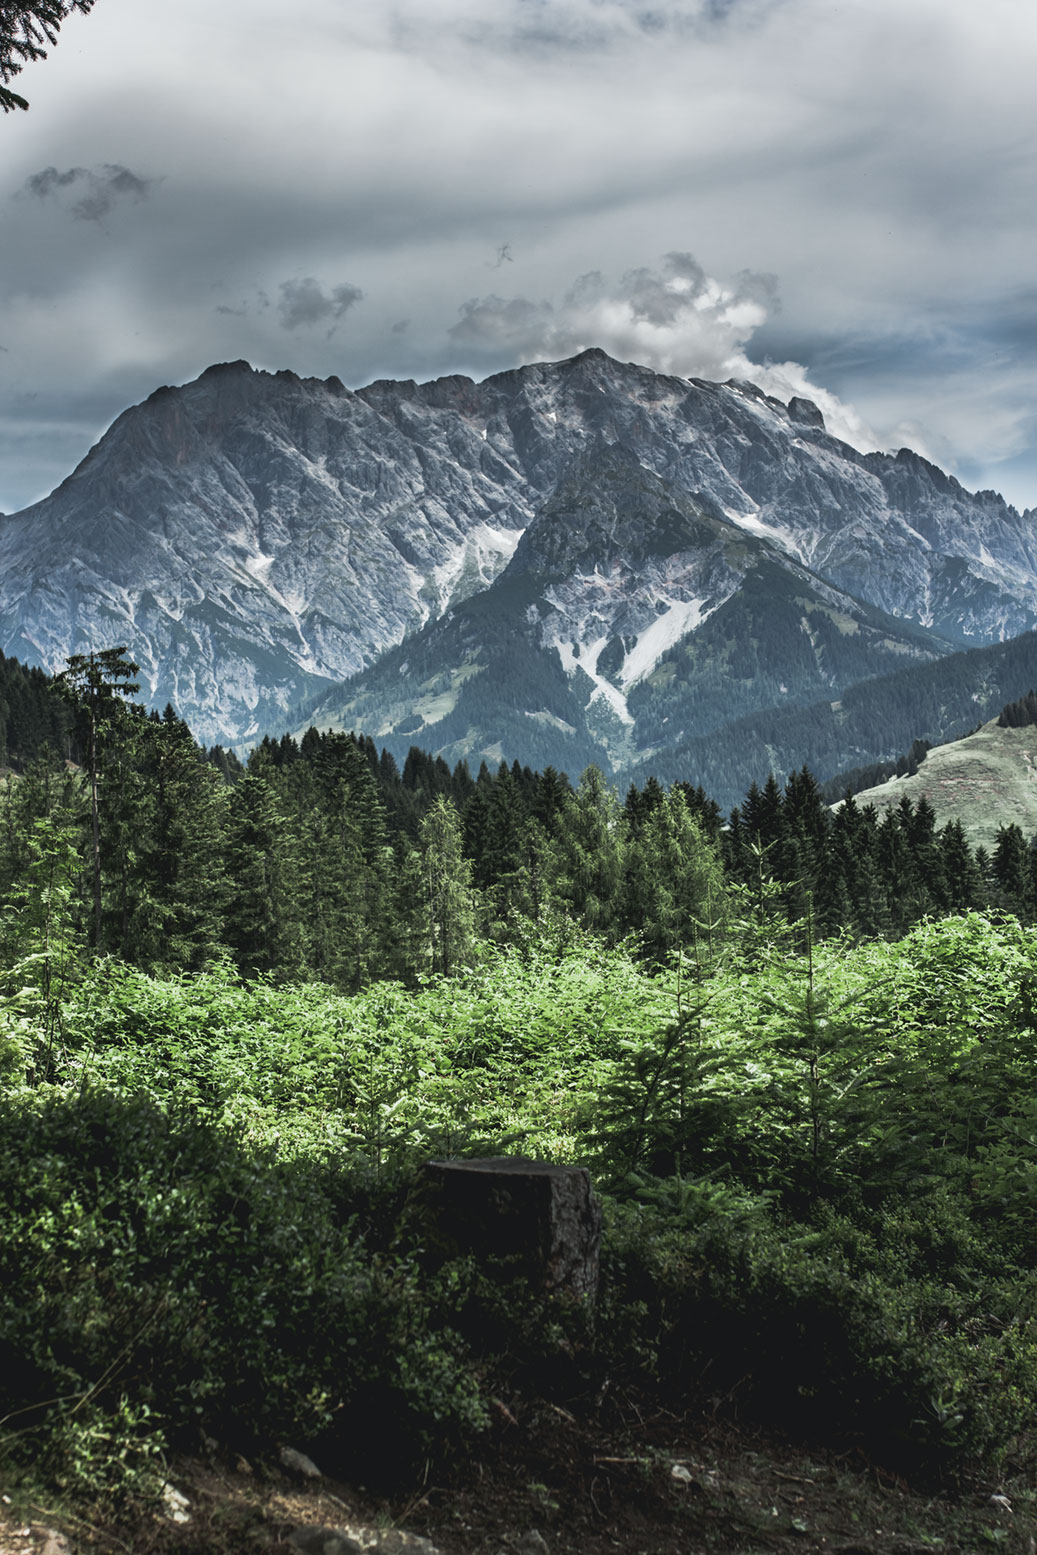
[426,1155,602,1302]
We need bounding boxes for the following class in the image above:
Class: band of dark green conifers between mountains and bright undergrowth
[0,655,1037,989]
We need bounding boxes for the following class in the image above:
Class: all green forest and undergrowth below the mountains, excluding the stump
[0,650,1037,1536]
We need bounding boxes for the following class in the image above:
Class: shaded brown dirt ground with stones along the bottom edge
[0,1398,1037,1555]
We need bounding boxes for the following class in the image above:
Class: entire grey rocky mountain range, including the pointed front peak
[0,350,1037,791]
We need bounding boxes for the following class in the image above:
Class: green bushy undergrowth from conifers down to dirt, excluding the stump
[0,914,1037,1505]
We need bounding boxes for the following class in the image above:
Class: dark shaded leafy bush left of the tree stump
[0,1090,485,1505]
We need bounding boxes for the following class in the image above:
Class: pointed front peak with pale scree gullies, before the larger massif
[309,443,950,771]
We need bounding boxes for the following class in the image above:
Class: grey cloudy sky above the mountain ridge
[0,0,1037,512]
